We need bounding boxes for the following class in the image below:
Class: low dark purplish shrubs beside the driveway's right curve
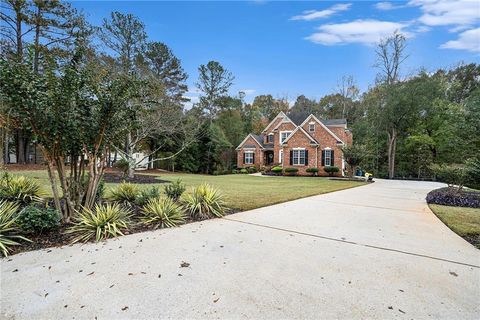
[426,188,480,208]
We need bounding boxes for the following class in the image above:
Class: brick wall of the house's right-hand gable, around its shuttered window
[303,121,343,176]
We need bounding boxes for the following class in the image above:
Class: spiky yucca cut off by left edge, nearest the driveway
[0,201,30,257]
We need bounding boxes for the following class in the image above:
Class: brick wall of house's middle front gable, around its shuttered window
[283,130,320,175]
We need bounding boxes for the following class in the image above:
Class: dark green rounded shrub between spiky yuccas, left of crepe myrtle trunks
[17,206,61,234]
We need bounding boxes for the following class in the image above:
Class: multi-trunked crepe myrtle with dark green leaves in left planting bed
[0,49,131,222]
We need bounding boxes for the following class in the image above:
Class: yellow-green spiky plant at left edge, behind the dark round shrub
[0,173,43,204]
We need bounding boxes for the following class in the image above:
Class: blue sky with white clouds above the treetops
[73,0,480,101]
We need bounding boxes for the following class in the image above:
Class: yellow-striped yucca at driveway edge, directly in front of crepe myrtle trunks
[67,203,131,243]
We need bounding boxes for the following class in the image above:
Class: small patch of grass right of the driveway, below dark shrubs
[429,204,480,249]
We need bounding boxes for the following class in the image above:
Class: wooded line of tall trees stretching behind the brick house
[0,0,480,187]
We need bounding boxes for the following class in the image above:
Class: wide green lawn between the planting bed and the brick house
[12,170,364,210]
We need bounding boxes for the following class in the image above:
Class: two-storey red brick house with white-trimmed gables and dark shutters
[236,112,352,176]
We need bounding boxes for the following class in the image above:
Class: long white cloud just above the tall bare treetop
[305,20,412,46]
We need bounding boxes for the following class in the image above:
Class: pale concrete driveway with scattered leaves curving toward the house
[1,178,480,319]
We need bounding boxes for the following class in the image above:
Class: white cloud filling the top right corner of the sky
[408,0,480,27]
